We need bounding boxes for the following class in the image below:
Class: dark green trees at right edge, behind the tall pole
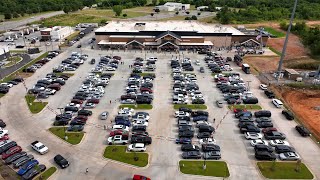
[280,22,320,56]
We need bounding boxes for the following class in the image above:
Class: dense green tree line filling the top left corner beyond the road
[0,0,96,19]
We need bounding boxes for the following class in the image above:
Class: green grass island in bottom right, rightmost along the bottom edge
[257,162,313,179]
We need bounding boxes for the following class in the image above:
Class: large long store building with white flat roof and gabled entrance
[95,21,267,51]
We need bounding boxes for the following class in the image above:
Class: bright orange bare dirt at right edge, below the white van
[277,88,320,139]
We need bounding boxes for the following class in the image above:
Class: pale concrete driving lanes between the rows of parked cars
[0,44,320,180]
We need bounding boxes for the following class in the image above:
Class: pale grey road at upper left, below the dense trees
[0,11,64,31]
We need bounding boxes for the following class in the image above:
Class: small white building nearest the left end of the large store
[40,26,74,41]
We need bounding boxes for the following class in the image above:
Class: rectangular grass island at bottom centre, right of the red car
[179,160,230,177]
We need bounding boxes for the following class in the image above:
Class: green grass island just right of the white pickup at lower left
[49,127,84,145]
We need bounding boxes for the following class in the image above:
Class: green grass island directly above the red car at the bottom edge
[103,146,149,167]
